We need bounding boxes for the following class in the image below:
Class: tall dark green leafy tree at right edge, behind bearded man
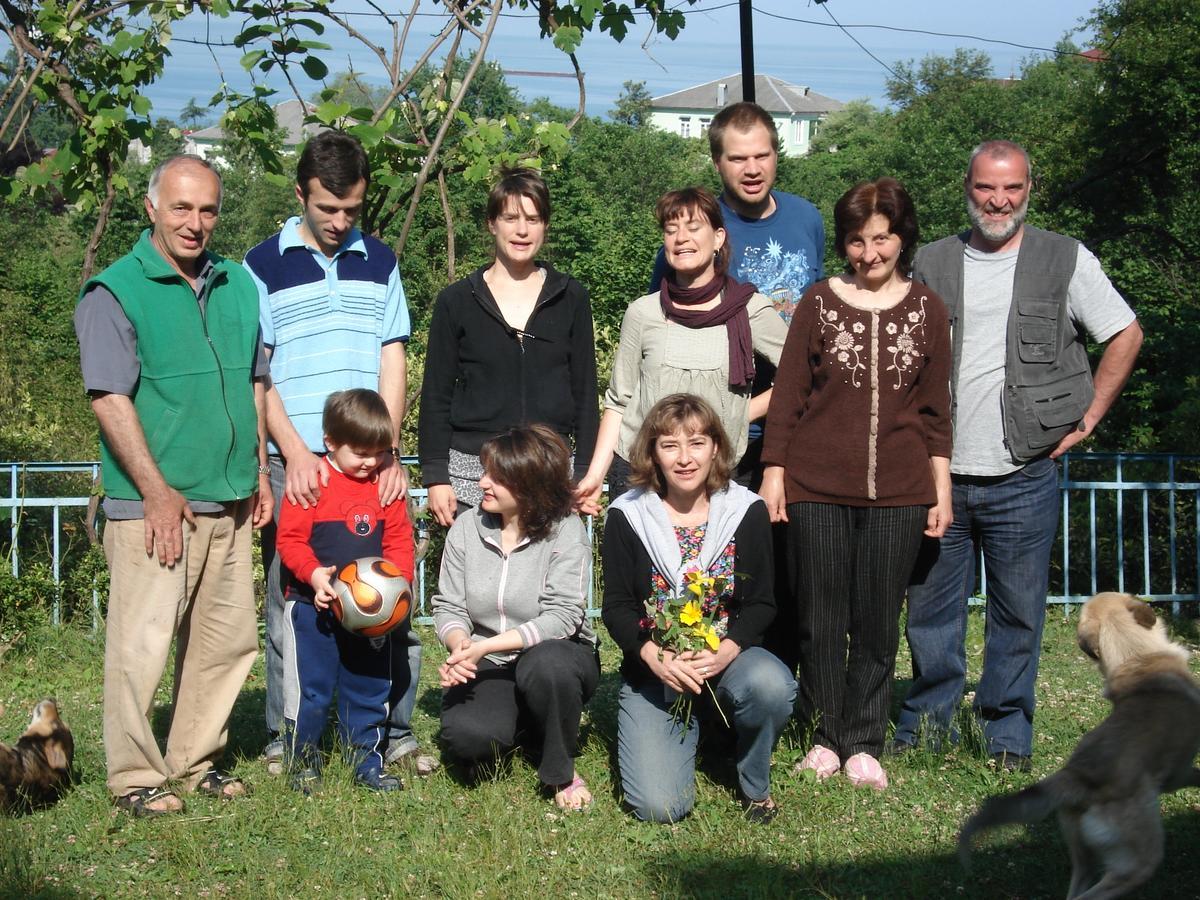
[1054,0,1200,451]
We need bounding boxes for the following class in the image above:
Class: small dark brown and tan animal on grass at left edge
[0,700,74,812]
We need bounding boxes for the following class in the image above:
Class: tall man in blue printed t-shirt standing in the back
[650,102,824,671]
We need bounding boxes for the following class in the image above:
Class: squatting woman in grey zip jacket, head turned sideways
[433,425,600,810]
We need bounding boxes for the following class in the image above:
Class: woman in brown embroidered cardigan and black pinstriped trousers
[760,178,950,791]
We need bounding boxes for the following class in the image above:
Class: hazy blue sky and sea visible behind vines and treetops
[146,0,1093,119]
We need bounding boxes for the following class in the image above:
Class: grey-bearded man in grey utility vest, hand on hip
[889,140,1141,770]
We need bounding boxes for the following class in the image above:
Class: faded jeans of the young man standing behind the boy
[263,456,421,756]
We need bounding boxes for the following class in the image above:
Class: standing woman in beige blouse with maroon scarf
[576,187,787,514]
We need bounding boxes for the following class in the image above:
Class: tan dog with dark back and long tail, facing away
[959,593,1200,900]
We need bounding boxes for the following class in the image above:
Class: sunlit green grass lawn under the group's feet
[0,611,1200,900]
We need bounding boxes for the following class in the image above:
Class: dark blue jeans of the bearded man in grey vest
[895,458,1060,756]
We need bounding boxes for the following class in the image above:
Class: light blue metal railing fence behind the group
[0,454,1200,625]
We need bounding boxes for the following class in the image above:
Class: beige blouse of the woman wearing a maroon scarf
[604,290,787,460]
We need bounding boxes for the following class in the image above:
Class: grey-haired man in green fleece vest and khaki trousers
[74,156,271,816]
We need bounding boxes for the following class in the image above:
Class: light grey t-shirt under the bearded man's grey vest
[950,244,1136,475]
